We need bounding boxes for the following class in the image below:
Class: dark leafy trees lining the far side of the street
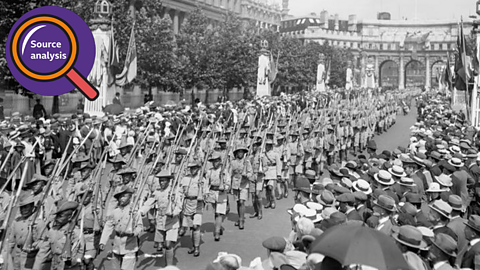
[0,0,352,100]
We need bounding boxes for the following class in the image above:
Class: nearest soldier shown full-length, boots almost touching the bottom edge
[140,170,183,265]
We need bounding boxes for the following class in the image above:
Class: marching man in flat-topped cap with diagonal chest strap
[262,140,282,209]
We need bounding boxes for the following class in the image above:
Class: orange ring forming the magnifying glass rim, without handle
[11,16,77,81]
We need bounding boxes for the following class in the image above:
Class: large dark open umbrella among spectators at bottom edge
[312,224,410,270]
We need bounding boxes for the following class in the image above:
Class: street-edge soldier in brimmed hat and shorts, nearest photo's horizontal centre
[229,145,253,230]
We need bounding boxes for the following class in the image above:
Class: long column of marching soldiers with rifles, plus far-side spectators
[0,87,416,269]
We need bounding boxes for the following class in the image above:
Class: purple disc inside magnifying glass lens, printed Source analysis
[19,23,71,73]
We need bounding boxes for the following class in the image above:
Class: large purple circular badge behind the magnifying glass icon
[6,6,95,96]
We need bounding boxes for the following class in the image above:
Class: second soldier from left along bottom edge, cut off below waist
[33,201,84,270]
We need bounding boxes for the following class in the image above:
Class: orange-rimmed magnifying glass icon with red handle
[10,15,99,101]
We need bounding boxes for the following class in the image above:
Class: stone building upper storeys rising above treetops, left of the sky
[162,0,288,34]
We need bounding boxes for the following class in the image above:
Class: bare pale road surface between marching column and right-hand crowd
[93,107,416,270]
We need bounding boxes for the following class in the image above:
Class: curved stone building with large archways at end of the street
[280,11,472,89]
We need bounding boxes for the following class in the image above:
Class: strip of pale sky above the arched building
[270,0,476,20]
